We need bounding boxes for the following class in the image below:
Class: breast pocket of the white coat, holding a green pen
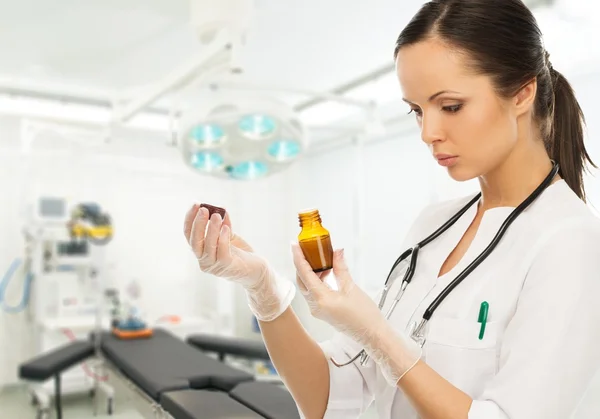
[424,316,499,398]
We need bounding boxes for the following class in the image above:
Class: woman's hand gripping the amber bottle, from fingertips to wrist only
[292,244,386,345]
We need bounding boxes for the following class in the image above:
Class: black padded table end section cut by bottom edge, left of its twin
[160,390,263,419]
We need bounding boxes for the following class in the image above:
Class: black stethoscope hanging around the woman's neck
[331,161,559,367]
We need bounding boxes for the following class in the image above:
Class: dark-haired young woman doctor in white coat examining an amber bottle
[185,0,600,419]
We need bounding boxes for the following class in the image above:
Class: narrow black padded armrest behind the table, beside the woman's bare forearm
[187,335,270,361]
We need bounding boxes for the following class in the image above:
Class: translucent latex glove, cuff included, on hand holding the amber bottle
[292,244,421,387]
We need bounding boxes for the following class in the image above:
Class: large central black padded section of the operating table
[100,329,254,401]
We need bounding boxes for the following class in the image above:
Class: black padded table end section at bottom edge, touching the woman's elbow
[229,381,300,419]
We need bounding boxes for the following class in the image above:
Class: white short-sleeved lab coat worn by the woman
[314,180,600,419]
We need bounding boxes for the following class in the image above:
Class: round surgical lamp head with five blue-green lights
[178,92,307,180]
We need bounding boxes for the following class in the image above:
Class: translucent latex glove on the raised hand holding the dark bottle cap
[184,204,296,321]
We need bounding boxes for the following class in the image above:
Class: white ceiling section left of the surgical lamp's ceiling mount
[0,0,194,92]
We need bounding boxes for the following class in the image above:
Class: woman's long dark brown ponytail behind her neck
[547,67,597,201]
